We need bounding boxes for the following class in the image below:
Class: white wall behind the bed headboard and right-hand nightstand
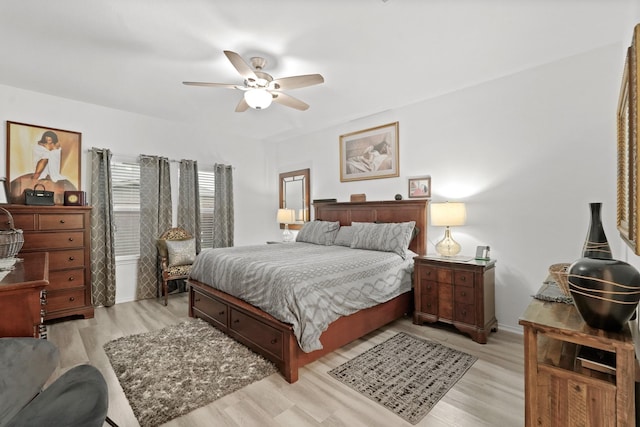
[274,39,630,332]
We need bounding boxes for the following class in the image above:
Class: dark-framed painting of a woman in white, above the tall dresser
[7,121,82,205]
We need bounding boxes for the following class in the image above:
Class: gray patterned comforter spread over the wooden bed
[190,242,415,352]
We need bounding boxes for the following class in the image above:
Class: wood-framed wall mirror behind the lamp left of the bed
[280,169,311,230]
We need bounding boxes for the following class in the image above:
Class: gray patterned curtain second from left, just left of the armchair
[136,156,171,299]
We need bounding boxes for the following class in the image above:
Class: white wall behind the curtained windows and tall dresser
[0,85,278,303]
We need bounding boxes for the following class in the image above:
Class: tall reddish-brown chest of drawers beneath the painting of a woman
[6,205,93,321]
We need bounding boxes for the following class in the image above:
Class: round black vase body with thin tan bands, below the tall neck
[567,258,640,331]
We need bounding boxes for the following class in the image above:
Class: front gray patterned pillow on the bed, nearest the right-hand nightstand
[351,221,416,259]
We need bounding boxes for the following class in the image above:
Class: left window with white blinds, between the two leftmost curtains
[111,160,140,257]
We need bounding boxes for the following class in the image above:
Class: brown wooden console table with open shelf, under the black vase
[519,299,636,427]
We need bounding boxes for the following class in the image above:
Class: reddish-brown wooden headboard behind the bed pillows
[313,199,429,255]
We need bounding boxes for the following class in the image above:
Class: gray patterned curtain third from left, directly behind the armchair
[178,160,200,253]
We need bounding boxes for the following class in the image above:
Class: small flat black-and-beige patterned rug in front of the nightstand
[329,332,477,424]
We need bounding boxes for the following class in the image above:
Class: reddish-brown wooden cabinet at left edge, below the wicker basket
[0,252,49,338]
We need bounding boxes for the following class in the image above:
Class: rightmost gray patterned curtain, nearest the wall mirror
[213,163,234,248]
